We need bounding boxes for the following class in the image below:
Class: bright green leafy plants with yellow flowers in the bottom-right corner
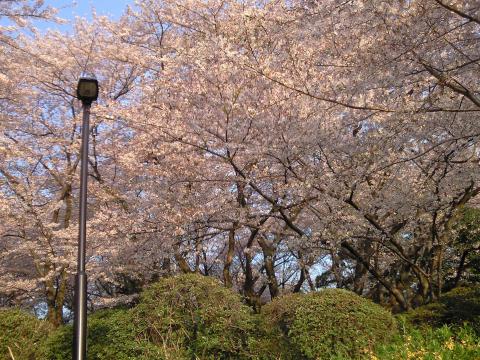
[376,317,480,360]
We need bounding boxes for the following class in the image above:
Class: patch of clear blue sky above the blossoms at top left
[35,0,134,32]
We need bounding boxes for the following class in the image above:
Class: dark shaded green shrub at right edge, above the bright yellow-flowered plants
[405,286,480,334]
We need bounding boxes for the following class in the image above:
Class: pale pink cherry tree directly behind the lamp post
[0,14,144,325]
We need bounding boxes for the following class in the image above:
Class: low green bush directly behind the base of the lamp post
[39,309,163,360]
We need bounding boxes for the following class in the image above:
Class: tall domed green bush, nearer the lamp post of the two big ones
[134,274,255,359]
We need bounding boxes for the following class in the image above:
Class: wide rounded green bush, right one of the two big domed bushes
[262,289,396,359]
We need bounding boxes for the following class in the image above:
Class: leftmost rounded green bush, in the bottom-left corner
[0,309,51,360]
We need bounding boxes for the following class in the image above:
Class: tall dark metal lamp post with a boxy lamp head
[73,77,98,360]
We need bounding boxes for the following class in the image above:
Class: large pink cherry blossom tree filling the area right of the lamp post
[113,1,478,308]
